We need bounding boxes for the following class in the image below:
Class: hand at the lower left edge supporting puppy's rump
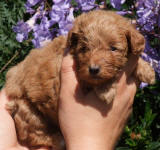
[0,89,52,150]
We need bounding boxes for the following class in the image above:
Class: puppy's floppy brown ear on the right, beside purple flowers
[127,27,145,55]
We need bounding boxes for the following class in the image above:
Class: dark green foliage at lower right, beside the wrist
[116,81,160,150]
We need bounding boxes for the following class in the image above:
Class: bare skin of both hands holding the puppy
[0,55,137,150]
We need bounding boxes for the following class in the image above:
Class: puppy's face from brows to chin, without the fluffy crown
[74,31,128,85]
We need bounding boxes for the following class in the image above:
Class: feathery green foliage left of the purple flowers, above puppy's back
[0,0,31,89]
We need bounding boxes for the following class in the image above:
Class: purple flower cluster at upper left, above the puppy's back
[13,0,98,47]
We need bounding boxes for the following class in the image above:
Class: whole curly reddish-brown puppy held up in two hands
[5,10,155,150]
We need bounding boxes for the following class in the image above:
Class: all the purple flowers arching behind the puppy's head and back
[13,0,160,81]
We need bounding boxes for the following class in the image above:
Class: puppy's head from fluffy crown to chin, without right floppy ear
[69,11,144,85]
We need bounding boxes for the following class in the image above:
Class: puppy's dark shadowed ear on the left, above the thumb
[67,31,79,54]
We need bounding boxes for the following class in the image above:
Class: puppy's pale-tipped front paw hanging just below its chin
[94,86,116,104]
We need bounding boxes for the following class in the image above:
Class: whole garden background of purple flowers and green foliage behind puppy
[0,0,160,150]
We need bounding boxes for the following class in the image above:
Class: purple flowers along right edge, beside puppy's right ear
[135,0,160,80]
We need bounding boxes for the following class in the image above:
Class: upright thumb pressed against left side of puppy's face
[61,54,78,90]
